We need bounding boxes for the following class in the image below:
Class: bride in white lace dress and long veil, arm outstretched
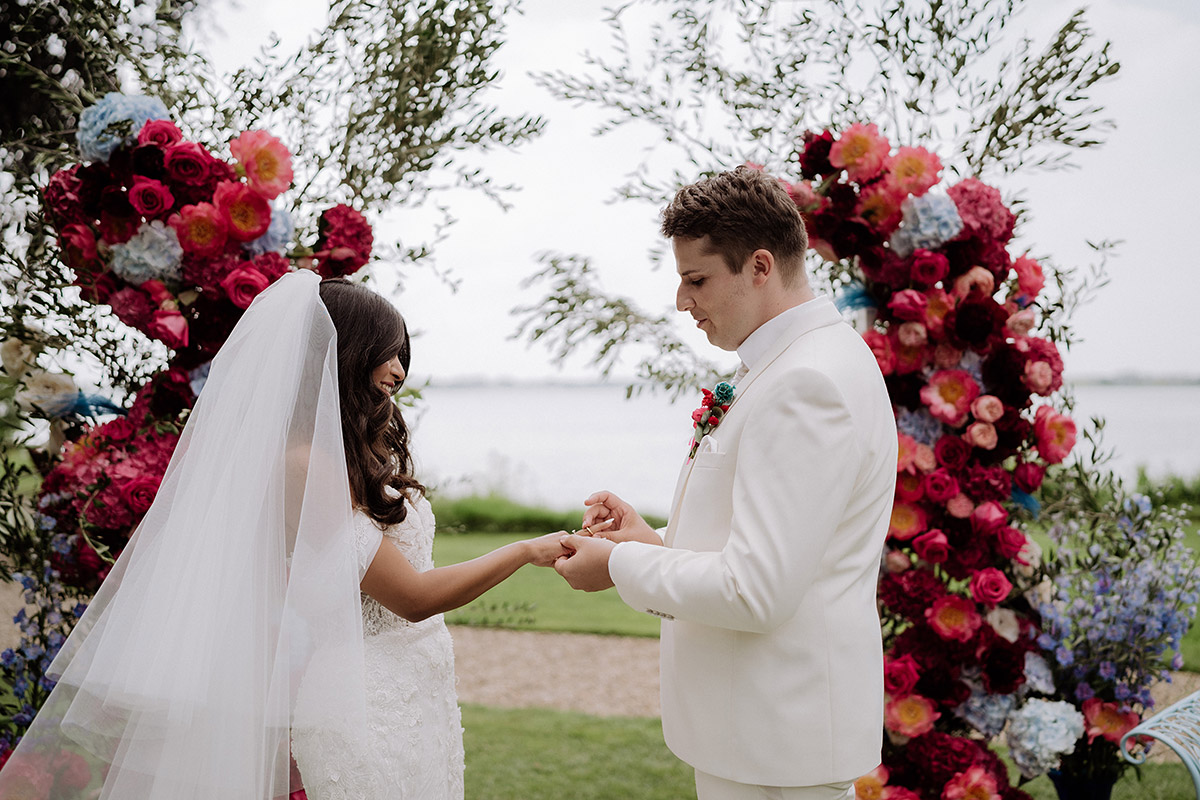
[0,271,563,800]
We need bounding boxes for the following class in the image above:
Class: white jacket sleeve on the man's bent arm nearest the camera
[608,369,862,633]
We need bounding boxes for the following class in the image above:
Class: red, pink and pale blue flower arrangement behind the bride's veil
[0,92,373,762]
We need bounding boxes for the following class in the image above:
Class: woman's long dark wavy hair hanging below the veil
[320,278,425,525]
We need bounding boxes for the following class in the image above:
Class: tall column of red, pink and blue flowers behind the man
[768,124,1190,800]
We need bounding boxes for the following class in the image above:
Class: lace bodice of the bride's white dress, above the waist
[354,497,442,636]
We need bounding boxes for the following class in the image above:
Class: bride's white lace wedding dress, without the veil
[292,497,463,800]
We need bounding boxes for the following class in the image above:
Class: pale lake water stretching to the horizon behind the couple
[412,384,1200,515]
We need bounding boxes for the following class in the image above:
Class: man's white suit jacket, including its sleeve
[608,297,896,786]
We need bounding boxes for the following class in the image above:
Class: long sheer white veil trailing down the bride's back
[0,271,366,800]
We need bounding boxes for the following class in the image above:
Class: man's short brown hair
[662,167,809,284]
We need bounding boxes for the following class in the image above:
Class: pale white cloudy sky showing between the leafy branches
[192,0,1200,380]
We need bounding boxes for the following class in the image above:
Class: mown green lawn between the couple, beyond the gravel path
[433,533,659,637]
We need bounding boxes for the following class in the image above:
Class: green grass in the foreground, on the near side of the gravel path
[462,705,1195,800]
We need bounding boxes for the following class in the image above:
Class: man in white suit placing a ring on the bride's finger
[556,168,896,800]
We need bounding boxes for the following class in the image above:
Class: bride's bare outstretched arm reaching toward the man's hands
[361,531,564,622]
